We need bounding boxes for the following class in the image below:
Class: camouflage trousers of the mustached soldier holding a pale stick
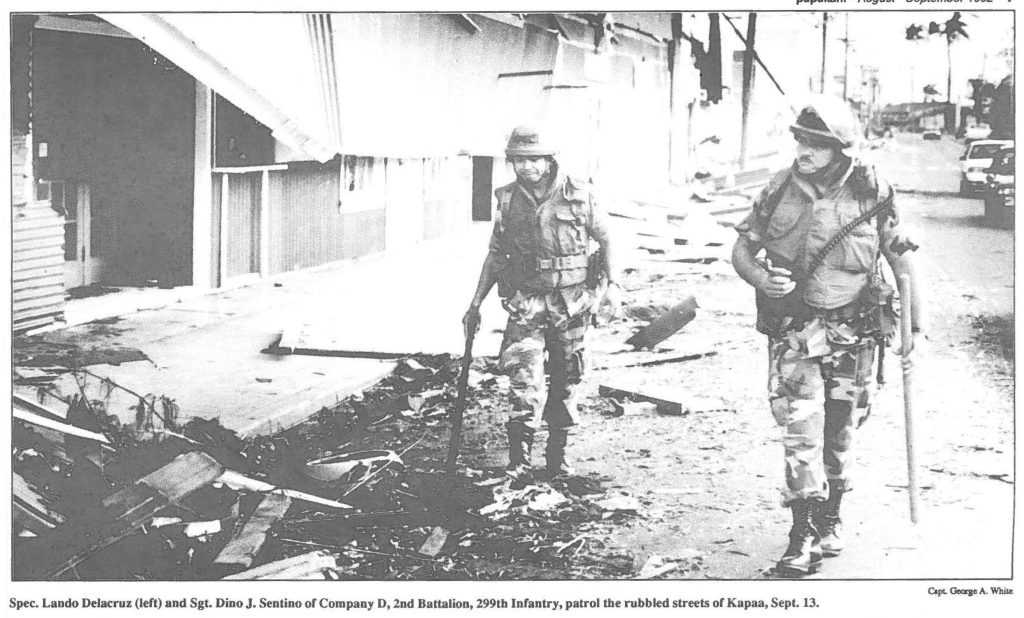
[768,318,876,505]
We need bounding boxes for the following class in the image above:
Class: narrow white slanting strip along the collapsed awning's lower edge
[94,13,339,163]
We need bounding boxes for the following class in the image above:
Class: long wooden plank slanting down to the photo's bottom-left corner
[14,451,223,579]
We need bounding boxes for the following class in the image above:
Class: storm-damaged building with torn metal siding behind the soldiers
[12,13,707,329]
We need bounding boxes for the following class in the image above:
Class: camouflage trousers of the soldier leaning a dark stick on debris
[500,292,591,429]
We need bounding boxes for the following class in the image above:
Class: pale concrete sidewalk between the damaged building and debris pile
[14,223,505,436]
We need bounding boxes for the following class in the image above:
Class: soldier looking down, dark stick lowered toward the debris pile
[463,127,621,482]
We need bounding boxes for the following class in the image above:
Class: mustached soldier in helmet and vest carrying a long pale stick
[732,97,923,576]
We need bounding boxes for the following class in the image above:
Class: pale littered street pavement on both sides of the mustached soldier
[571,134,1015,579]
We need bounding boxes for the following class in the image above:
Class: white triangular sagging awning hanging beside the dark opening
[97,13,339,163]
